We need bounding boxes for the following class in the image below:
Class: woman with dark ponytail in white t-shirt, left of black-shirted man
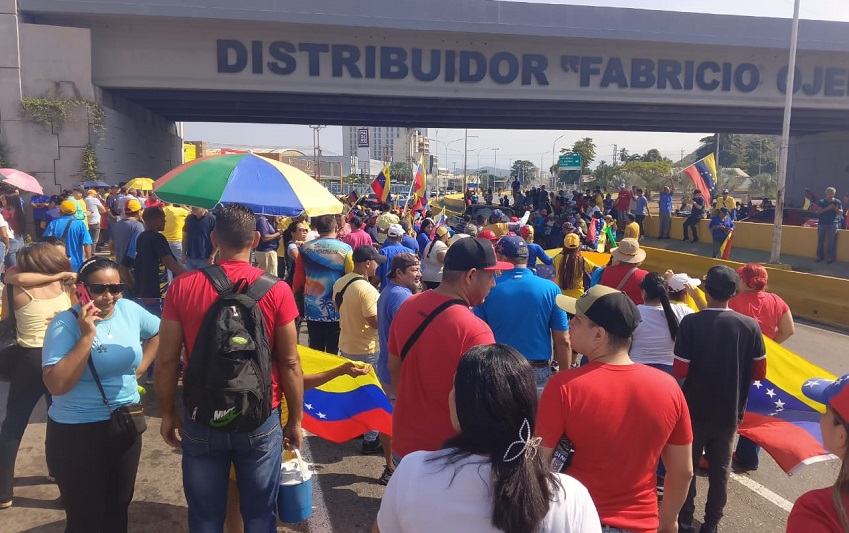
[631,272,693,375]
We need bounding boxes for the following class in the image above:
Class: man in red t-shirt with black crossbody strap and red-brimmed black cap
[387,237,506,463]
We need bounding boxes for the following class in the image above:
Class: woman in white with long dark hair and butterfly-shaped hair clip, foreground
[372,344,601,533]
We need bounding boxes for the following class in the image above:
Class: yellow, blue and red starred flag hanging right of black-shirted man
[738,337,835,475]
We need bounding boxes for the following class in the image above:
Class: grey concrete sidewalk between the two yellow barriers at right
[640,235,849,279]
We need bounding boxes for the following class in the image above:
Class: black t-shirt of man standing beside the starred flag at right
[675,309,766,427]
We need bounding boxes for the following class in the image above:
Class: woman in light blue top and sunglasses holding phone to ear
[42,258,159,533]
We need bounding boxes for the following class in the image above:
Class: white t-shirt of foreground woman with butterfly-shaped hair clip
[377,451,601,533]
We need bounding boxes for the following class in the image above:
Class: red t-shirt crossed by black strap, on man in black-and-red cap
[388,291,495,457]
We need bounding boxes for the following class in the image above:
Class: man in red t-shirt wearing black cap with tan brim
[536,285,693,533]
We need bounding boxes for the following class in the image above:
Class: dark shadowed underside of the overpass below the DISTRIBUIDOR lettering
[112,89,849,135]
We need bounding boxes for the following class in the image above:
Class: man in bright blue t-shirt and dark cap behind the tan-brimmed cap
[472,235,572,393]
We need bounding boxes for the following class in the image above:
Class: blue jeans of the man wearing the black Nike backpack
[183,409,283,533]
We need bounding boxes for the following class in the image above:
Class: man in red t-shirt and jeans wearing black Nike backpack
[155,204,303,531]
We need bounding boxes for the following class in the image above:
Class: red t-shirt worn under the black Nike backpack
[162,261,298,407]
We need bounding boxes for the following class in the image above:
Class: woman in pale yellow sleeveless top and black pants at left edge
[0,237,75,509]
